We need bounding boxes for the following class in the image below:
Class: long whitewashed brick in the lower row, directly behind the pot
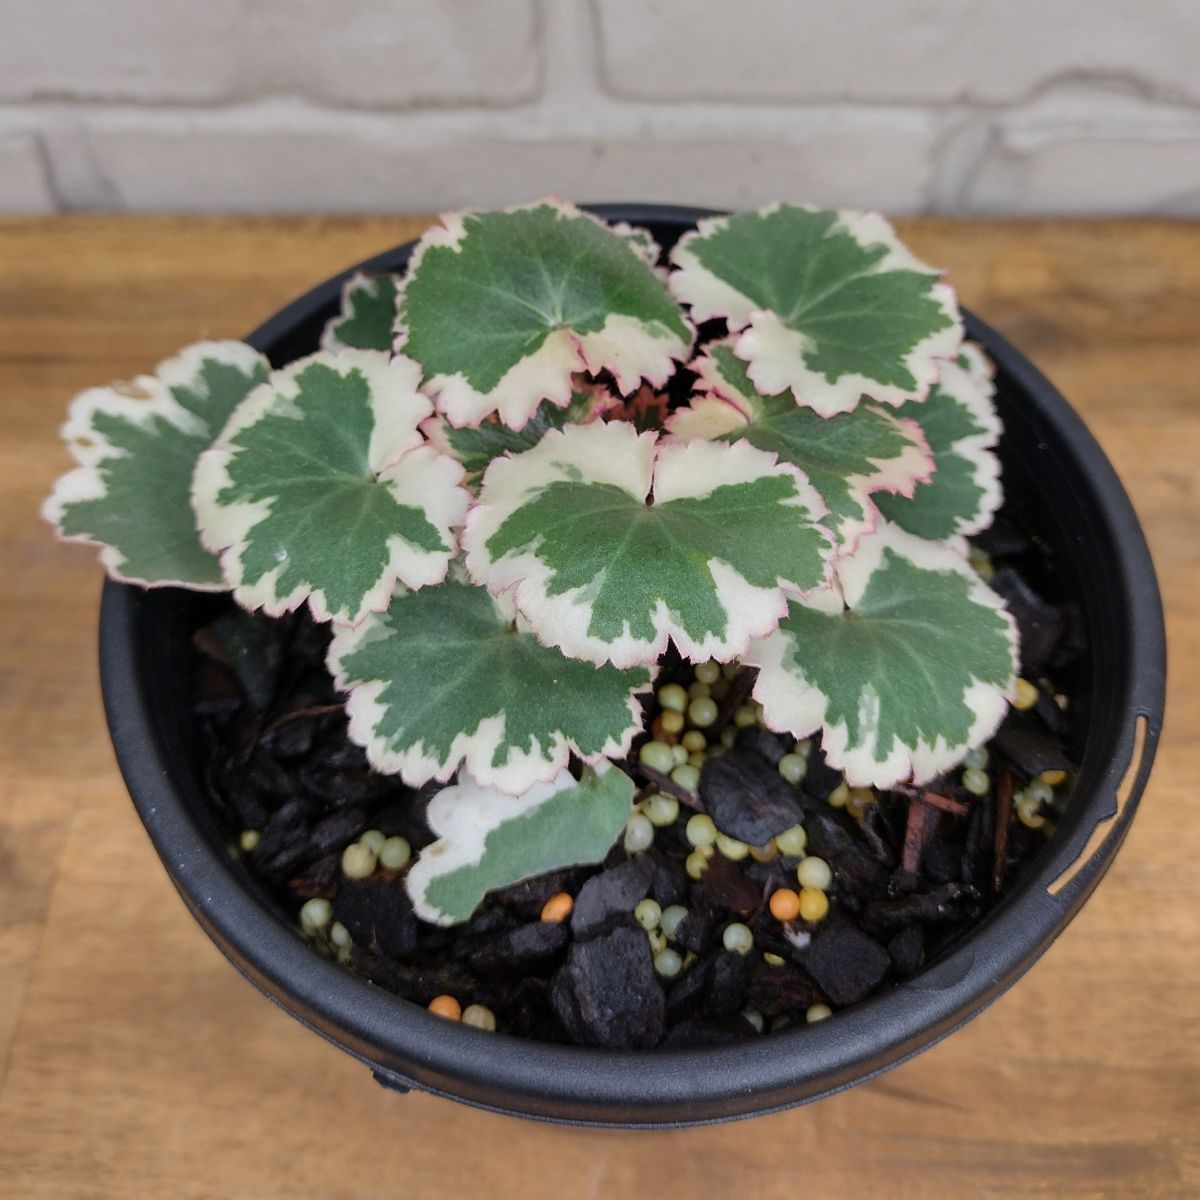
[89,103,936,212]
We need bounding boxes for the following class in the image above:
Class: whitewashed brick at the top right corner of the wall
[593,0,1200,103]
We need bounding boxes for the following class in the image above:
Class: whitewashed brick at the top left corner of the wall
[0,0,539,108]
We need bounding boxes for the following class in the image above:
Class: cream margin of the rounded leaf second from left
[192,350,470,625]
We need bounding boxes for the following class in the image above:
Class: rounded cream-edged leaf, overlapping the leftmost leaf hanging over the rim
[193,350,469,623]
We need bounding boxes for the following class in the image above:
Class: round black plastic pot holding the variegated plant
[101,205,1166,1126]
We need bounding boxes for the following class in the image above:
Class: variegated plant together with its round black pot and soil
[47,200,1162,1123]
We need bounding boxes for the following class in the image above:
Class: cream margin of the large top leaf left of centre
[395,196,695,430]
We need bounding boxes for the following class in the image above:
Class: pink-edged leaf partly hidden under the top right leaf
[667,342,931,551]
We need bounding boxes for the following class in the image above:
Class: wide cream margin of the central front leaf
[462,421,832,667]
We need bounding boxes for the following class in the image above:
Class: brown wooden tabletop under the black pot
[0,217,1200,1200]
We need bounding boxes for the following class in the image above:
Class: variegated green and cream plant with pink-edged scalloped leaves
[44,199,1016,923]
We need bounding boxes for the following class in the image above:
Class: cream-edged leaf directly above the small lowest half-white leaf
[329,578,652,793]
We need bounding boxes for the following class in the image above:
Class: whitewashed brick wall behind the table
[0,0,1200,215]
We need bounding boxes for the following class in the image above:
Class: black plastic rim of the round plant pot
[101,204,1165,1126]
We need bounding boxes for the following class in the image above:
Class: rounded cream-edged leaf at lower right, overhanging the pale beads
[746,523,1016,787]
